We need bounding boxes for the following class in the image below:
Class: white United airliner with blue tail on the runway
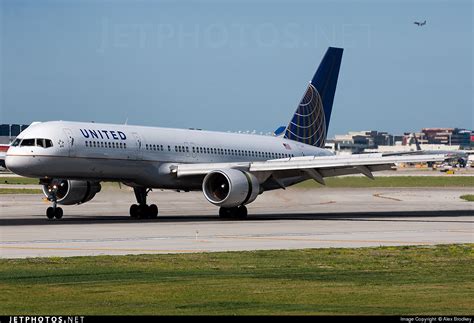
[5,47,444,219]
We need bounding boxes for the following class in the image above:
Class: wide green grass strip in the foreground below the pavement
[0,244,474,315]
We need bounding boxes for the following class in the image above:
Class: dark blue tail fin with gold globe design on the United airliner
[284,47,343,147]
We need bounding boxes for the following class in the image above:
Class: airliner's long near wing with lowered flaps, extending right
[171,154,446,184]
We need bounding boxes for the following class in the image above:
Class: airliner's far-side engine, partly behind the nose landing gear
[43,179,101,205]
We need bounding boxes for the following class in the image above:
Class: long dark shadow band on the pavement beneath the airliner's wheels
[0,210,474,227]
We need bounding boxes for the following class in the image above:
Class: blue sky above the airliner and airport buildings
[0,0,474,135]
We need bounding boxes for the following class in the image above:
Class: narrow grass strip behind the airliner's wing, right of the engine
[295,174,474,188]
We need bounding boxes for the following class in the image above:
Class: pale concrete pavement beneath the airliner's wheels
[0,187,474,258]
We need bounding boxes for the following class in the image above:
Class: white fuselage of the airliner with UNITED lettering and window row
[6,121,332,189]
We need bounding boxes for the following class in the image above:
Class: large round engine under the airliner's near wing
[202,169,260,207]
